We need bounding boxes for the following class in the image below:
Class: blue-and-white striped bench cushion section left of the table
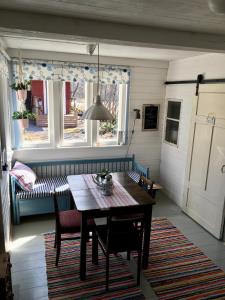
[16,176,69,199]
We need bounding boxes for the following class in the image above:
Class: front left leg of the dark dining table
[80,213,87,280]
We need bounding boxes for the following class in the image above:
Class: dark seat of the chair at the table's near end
[97,221,140,253]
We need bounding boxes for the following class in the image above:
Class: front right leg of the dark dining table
[142,206,152,269]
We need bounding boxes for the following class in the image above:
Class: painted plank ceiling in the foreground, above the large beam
[0,0,225,34]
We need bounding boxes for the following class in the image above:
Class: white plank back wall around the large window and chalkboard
[9,49,168,179]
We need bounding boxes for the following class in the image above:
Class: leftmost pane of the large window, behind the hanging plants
[17,80,49,145]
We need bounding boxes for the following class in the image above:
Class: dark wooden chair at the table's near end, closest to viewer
[97,206,144,290]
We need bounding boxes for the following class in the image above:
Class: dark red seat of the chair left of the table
[59,209,95,233]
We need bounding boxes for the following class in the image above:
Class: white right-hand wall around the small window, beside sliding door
[160,54,225,205]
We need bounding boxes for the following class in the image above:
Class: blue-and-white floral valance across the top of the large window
[13,60,130,84]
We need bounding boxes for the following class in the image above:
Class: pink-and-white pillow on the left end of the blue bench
[10,161,37,192]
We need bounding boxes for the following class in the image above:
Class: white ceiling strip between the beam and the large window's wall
[1,35,206,61]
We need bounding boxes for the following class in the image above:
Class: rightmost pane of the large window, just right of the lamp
[97,84,119,144]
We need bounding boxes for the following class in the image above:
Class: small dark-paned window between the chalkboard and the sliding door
[165,100,181,145]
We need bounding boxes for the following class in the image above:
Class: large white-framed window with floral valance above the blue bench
[12,61,129,148]
